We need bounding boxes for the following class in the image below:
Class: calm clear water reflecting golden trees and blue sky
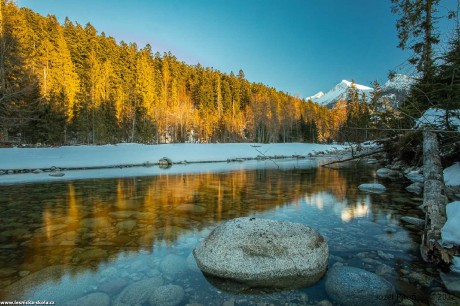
[0,160,440,305]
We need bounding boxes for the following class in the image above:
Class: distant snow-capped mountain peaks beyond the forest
[305,74,416,107]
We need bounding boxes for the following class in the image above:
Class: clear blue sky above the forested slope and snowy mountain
[17,0,456,97]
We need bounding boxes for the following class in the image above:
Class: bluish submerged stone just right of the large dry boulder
[326,267,397,306]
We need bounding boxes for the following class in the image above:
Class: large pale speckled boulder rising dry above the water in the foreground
[193,218,329,289]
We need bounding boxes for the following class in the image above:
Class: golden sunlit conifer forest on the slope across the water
[0,0,338,145]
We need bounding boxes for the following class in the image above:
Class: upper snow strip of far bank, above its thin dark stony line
[0,143,342,170]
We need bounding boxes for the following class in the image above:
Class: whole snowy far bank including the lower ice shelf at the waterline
[0,143,344,184]
